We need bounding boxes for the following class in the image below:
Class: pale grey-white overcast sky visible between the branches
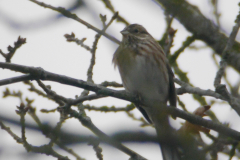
[0,0,240,160]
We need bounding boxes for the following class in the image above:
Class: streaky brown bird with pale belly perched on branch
[113,24,180,160]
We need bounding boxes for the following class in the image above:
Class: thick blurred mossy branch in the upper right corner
[155,0,240,72]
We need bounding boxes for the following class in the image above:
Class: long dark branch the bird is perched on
[0,62,240,140]
